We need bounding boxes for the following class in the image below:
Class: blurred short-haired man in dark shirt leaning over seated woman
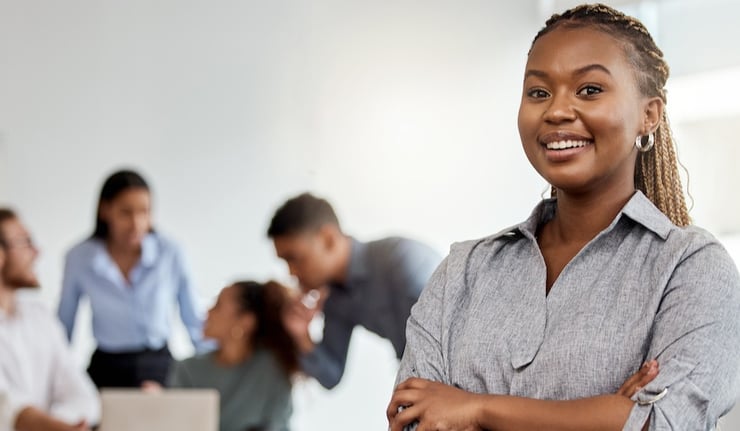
[267,193,441,388]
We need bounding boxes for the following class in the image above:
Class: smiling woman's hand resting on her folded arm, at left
[386,378,483,431]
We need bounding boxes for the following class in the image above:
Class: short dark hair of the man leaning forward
[267,193,339,238]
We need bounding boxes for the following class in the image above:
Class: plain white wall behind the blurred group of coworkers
[0,0,737,431]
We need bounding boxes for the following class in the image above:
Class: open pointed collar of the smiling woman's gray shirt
[492,190,674,240]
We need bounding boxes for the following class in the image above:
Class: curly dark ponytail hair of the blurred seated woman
[233,281,300,375]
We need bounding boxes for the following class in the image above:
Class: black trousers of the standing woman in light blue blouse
[87,346,172,388]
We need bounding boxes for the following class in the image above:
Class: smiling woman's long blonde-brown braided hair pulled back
[532,4,691,226]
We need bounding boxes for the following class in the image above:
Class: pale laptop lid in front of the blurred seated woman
[97,389,219,431]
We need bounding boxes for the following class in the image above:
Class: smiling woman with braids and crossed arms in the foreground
[387,5,740,431]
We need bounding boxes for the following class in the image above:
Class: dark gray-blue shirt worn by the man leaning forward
[301,237,442,388]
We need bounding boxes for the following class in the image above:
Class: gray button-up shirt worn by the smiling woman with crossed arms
[398,192,740,431]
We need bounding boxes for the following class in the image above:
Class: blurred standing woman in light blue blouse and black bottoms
[59,171,204,387]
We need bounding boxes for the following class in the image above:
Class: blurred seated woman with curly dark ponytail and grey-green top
[168,281,299,431]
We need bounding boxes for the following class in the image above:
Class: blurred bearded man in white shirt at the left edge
[0,208,100,431]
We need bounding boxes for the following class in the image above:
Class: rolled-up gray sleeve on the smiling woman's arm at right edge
[624,243,740,430]
